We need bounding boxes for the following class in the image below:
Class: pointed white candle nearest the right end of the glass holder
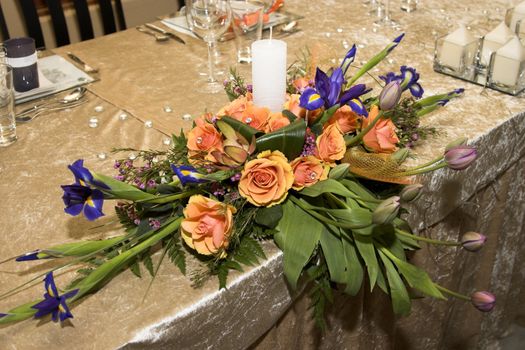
[492,37,525,86]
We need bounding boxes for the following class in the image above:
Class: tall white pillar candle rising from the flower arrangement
[252,39,286,112]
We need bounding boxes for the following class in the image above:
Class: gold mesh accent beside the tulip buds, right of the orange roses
[343,148,414,185]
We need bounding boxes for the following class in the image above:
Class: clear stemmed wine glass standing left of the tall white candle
[186,0,232,93]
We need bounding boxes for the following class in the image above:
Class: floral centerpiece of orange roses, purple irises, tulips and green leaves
[0,35,495,326]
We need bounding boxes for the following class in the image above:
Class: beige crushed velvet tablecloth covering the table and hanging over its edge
[0,0,525,350]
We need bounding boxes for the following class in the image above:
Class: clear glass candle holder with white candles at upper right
[434,36,525,96]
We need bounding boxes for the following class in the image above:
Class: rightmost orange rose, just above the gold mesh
[363,106,399,153]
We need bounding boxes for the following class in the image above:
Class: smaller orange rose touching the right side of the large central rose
[290,156,330,190]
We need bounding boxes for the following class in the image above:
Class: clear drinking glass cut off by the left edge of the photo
[0,63,16,147]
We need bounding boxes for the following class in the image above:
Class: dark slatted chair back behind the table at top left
[17,0,126,48]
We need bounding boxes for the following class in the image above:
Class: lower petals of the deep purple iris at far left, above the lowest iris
[61,184,104,221]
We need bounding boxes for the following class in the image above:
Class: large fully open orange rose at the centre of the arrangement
[239,151,294,207]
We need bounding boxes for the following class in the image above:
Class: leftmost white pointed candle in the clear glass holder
[439,25,477,70]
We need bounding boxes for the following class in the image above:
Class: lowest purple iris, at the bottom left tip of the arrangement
[31,272,78,322]
